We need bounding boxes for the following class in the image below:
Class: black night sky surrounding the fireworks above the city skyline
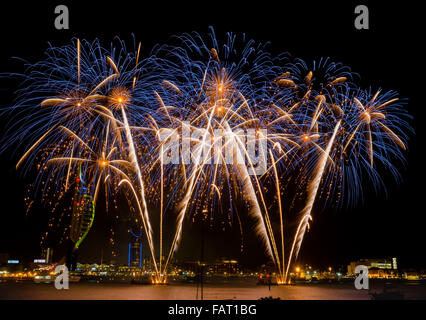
[0,1,426,268]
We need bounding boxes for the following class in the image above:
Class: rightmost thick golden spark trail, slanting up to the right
[285,120,341,280]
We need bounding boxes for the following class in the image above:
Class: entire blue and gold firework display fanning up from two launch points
[2,29,412,284]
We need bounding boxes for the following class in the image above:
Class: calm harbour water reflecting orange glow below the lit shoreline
[0,278,426,300]
